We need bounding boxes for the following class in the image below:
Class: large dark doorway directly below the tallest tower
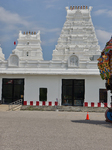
[62,79,85,106]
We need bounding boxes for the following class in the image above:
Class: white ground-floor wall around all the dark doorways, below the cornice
[0,75,107,105]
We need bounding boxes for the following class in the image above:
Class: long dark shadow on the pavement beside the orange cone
[71,120,112,128]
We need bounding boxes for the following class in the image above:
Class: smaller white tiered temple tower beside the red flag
[11,31,43,60]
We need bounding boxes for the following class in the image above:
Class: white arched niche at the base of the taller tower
[68,54,79,68]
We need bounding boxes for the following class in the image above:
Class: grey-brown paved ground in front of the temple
[0,111,112,150]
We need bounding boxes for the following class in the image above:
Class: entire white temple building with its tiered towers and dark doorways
[0,6,110,106]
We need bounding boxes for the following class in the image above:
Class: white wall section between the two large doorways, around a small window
[24,75,60,105]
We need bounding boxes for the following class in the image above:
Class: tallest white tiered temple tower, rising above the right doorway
[52,6,101,62]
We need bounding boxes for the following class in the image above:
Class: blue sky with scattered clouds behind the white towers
[0,0,112,60]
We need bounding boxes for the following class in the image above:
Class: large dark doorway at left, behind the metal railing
[2,79,24,104]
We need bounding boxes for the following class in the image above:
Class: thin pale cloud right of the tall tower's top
[94,9,112,17]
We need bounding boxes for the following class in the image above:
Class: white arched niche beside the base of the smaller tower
[8,54,19,67]
